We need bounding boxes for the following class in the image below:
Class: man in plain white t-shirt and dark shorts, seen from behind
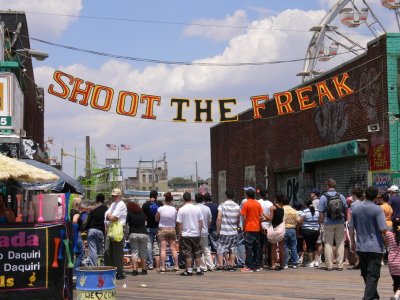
[176,192,204,276]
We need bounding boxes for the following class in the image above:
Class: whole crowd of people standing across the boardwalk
[71,179,400,299]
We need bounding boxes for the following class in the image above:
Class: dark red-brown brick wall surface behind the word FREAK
[210,37,388,201]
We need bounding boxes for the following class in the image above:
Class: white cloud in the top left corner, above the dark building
[0,0,83,37]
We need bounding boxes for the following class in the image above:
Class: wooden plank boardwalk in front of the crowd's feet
[74,266,392,300]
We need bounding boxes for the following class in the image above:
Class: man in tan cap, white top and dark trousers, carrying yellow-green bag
[104,189,127,280]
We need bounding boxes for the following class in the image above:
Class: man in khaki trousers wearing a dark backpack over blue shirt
[318,179,347,271]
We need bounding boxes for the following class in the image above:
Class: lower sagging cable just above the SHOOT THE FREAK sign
[25,36,361,67]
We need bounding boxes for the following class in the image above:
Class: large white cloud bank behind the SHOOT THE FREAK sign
[35,10,324,183]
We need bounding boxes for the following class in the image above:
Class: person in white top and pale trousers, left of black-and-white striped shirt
[195,193,215,272]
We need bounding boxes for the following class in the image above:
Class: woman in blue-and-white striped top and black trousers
[300,199,319,268]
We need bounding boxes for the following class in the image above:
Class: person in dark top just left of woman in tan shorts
[142,190,162,270]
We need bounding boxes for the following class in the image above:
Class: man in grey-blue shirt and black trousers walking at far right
[350,187,387,300]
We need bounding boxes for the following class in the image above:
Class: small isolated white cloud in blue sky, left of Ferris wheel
[184,10,249,41]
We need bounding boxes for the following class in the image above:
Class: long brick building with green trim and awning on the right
[210,34,400,204]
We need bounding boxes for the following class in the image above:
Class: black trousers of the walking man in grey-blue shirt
[357,251,383,300]
